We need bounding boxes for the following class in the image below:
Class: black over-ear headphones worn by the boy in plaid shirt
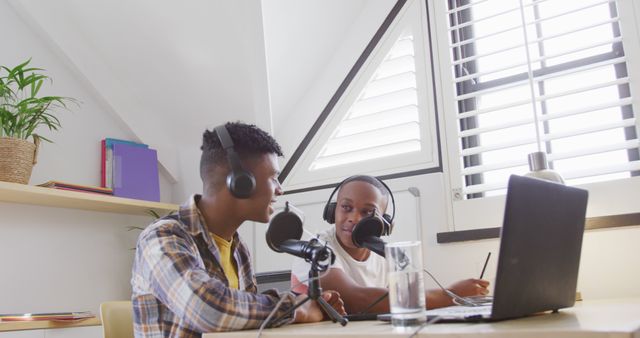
[214,125,256,198]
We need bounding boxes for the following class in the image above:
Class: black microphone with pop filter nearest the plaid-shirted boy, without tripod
[266,202,336,271]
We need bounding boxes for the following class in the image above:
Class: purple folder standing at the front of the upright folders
[113,143,160,201]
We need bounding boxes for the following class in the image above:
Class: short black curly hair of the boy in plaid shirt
[200,121,283,181]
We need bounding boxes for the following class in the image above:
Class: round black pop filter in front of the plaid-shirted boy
[266,202,303,252]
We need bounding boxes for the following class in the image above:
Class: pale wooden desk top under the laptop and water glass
[203,298,640,338]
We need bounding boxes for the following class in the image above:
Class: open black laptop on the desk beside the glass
[418,175,588,321]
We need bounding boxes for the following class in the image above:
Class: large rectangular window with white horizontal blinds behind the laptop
[436,0,640,230]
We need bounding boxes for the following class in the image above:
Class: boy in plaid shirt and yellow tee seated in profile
[131,122,345,337]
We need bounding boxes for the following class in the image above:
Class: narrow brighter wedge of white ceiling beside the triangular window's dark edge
[263,0,368,129]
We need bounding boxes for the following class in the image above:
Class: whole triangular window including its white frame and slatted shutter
[284,0,440,191]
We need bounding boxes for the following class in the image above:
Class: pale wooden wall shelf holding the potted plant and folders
[0,182,179,215]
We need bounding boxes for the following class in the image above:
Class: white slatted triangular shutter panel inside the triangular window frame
[309,30,421,171]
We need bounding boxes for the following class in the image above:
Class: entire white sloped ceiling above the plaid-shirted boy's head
[8,0,395,182]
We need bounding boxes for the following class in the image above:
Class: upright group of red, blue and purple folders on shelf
[101,138,160,201]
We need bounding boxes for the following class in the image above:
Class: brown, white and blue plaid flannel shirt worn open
[131,195,295,337]
